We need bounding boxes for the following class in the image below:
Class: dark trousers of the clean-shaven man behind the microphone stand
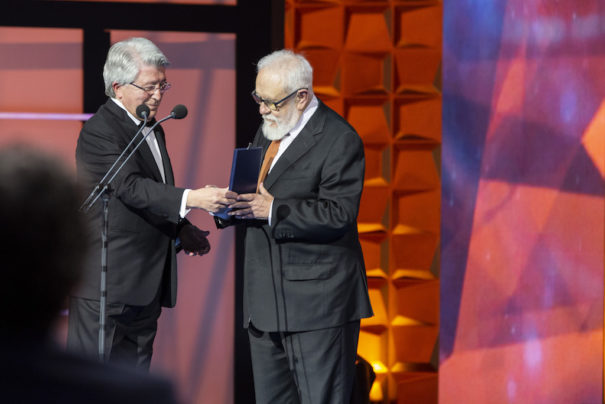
[67,297,162,370]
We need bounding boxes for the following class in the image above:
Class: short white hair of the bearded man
[256,49,313,93]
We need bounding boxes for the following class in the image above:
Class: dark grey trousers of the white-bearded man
[248,321,359,404]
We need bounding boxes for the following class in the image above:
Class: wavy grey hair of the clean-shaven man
[103,38,170,98]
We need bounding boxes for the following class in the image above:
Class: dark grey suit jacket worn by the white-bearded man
[219,102,373,331]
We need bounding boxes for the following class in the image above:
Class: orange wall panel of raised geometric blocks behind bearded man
[285,0,442,404]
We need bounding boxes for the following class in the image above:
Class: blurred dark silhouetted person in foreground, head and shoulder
[0,146,176,404]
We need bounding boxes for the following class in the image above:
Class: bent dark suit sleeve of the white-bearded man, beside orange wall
[272,128,365,242]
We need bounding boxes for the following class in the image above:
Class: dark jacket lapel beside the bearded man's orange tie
[264,101,325,190]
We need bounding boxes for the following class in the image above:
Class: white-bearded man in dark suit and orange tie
[222,50,373,404]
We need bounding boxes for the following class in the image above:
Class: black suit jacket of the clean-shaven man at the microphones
[74,99,184,307]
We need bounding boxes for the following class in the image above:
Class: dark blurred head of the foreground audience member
[0,146,87,336]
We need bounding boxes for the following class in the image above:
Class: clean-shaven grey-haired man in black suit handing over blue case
[67,38,235,369]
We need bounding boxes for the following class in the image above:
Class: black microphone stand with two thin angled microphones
[80,107,182,361]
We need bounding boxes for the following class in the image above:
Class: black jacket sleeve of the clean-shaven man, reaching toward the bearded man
[76,116,184,223]
